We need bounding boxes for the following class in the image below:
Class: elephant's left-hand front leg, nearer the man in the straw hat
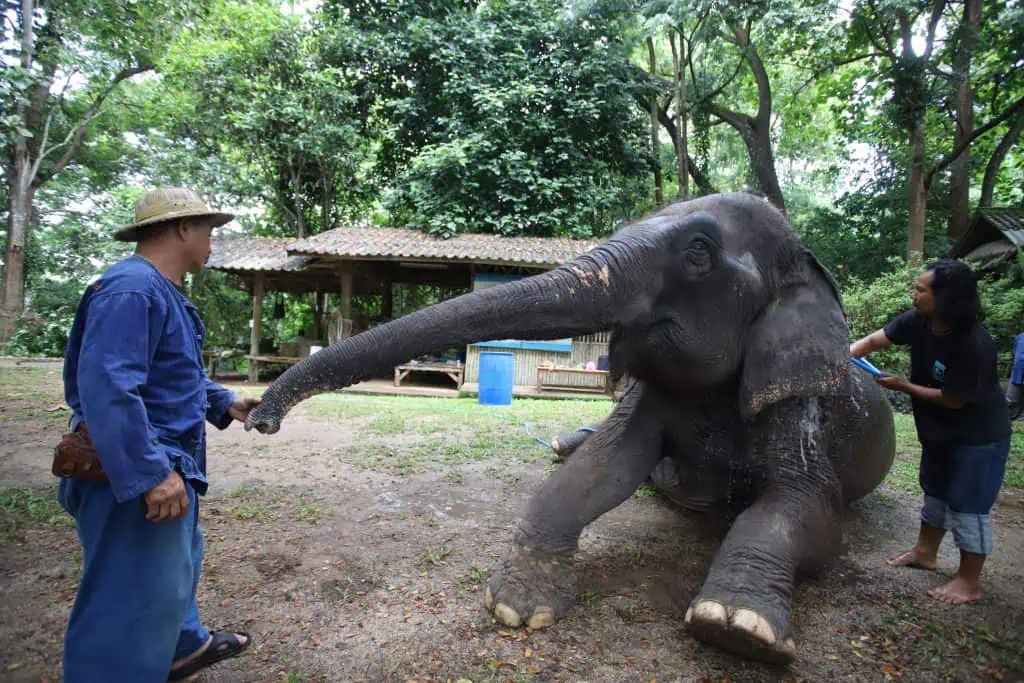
[484,395,665,629]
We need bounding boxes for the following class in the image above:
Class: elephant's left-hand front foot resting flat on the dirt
[484,547,575,629]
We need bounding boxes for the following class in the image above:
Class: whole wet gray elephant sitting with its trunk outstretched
[246,194,894,663]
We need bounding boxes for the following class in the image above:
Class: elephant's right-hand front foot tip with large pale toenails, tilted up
[686,599,797,665]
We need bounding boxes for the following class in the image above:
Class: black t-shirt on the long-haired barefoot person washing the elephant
[884,310,1010,445]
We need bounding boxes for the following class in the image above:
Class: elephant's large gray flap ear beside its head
[739,249,850,420]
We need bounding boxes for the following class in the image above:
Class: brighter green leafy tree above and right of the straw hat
[162,0,375,236]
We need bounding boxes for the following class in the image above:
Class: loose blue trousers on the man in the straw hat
[57,479,210,683]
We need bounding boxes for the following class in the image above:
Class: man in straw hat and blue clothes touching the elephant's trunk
[57,187,259,683]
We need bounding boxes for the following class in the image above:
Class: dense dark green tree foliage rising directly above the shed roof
[372,0,647,238]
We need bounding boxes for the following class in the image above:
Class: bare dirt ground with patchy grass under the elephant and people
[0,362,1024,683]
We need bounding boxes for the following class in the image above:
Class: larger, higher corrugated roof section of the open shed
[288,224,600,266]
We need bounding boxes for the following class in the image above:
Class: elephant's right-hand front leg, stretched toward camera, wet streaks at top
[686,399,842,664]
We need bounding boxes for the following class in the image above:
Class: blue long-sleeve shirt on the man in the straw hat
[63,255,237,502]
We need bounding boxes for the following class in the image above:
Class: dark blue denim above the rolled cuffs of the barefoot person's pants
[919,434,1010,515]
